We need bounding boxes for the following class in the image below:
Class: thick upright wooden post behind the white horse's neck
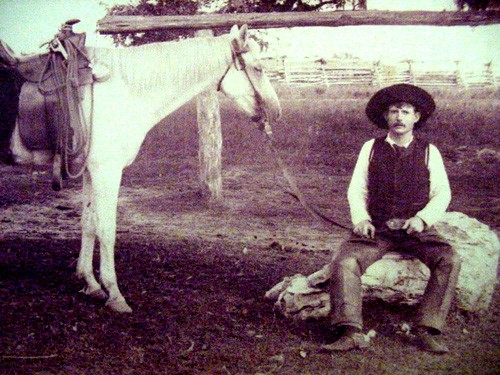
[196,30,222,201]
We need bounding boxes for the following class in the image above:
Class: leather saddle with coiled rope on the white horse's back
[0,19,94,190]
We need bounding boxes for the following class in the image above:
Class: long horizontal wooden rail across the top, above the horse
[97,10,500,34]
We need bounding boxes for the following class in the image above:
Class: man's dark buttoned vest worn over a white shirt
[368,137,430,228]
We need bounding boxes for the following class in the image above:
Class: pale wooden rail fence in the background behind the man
[264,58,500,89]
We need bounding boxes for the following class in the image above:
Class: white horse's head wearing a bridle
[218,25,281,126]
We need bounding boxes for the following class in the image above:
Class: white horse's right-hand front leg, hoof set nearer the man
[90,166,132,312]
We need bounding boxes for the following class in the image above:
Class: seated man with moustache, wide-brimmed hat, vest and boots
[322,84,460,353]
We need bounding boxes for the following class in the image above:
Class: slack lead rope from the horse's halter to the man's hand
[259,121,352,231]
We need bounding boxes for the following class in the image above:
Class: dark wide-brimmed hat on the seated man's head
[366,83,436,129]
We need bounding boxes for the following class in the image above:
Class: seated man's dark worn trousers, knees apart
[330,228,461,332]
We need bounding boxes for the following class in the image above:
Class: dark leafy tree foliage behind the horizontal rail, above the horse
[108,0,367,45]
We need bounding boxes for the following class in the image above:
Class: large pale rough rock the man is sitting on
[266,212,500,320]
